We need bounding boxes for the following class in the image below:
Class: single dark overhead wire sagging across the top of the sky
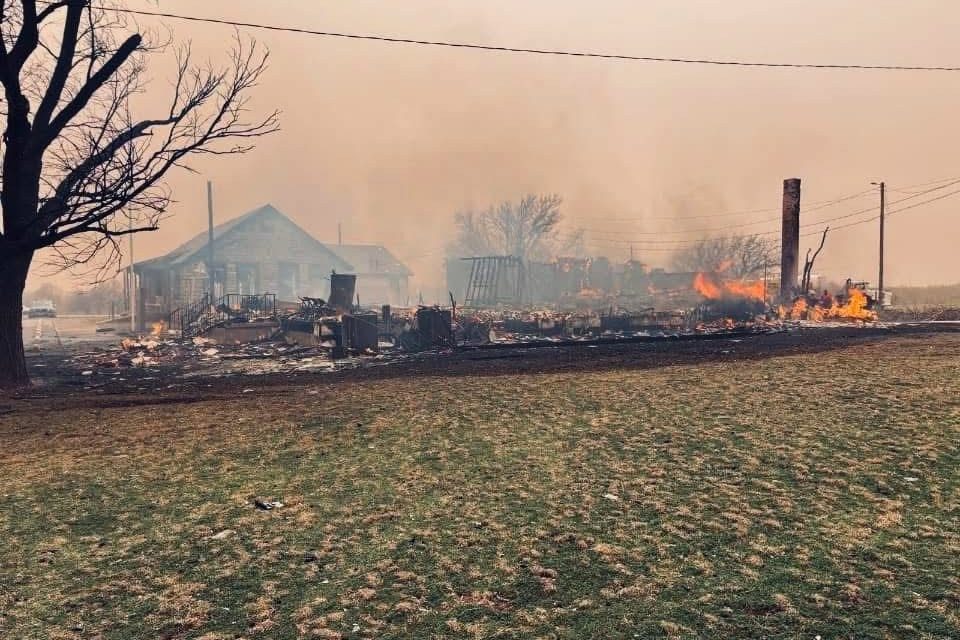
[97,6,960,73]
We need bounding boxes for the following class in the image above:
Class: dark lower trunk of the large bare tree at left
[0,253,33,389]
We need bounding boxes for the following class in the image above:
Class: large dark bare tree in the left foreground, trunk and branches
[0,0,278,388]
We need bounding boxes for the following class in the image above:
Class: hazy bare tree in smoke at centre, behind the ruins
[450,194,582,260]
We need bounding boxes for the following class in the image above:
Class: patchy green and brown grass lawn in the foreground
[0,334,960,640]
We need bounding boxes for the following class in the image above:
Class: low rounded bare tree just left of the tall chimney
[673,235,776,278]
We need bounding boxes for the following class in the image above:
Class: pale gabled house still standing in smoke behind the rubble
[134,204,410,325]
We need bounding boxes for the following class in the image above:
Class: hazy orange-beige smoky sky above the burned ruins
[28,0,960,287]
